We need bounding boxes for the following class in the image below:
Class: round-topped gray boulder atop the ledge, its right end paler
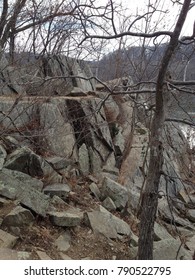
[22,55,94,96]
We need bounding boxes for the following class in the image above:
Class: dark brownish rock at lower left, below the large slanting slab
[3,206,34,227]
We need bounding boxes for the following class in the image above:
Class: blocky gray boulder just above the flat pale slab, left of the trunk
[101,177,128,209]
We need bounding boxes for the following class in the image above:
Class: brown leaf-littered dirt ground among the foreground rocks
[0,178,139,260]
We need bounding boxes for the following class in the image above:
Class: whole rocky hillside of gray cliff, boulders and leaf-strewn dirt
[0,53,195,259]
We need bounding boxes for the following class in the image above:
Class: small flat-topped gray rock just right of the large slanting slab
[43,183,71,200]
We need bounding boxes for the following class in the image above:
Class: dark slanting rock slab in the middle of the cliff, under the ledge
[67,97,114,174]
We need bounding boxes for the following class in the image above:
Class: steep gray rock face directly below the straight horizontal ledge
[0,96,115,174]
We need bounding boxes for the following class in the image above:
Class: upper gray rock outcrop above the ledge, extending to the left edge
[0,55,94,96]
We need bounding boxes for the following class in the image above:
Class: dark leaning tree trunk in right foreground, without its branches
[138,0,191,260]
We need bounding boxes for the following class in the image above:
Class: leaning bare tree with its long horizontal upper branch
[79,0,194,259]
